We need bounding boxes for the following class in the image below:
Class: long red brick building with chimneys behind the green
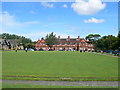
[35,36,94,51]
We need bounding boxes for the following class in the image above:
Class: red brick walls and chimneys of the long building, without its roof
[35,36,94,51]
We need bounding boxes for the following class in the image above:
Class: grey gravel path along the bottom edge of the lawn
[0,80,118,87]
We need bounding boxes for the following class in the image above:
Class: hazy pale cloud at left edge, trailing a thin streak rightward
[0,11,40,33]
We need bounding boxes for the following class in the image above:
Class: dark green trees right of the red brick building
[86,31,120,51]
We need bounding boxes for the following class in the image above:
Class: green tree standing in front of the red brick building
[45,32,58,48]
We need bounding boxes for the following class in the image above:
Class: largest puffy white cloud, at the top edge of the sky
[71,0,106,15]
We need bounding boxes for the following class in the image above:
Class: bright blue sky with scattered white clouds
[0,0,118,41]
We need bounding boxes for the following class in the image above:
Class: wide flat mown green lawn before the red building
[2,51,118,80]
